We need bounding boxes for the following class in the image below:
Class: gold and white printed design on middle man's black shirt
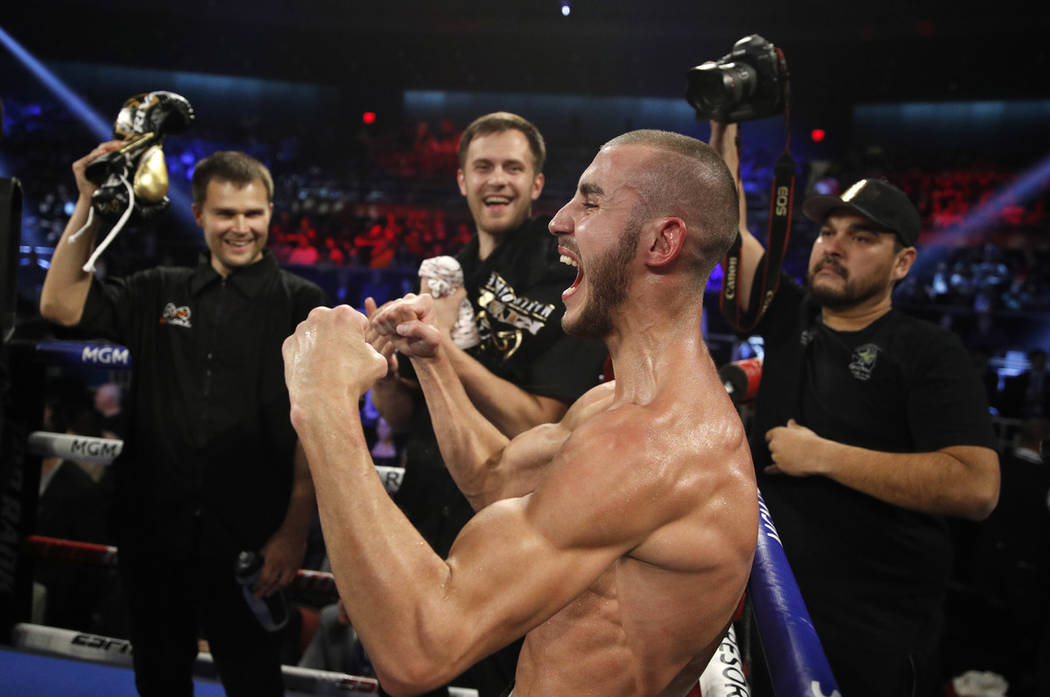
[476,272,555,360]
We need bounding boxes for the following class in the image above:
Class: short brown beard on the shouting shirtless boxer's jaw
[565,216,642,339]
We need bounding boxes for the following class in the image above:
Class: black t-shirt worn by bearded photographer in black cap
[751,276,995,649]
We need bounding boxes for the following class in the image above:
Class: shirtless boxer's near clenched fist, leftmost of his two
[281,305,386,410]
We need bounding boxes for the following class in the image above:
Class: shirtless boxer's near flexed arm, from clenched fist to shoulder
[284,305,663,695]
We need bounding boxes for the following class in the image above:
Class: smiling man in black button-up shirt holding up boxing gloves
[40,143,324,696]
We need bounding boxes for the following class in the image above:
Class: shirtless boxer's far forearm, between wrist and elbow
[412,341,510,510]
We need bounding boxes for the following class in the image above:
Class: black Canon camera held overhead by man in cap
[686,34,788,123]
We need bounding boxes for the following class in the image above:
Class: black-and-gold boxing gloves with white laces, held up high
[69,91,194,272]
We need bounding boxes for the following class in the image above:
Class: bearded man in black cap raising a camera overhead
[712,124,999,697]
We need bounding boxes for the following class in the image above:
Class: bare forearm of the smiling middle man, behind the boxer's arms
[441,336,568,438]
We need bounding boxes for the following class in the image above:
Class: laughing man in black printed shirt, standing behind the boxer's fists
[372,111,607,697]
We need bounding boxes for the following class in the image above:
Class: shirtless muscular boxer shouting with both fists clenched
[285,131,758,697]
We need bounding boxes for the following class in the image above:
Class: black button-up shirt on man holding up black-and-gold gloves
[79,251,326,557]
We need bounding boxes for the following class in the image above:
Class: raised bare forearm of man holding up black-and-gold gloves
[40,141,121,326]
